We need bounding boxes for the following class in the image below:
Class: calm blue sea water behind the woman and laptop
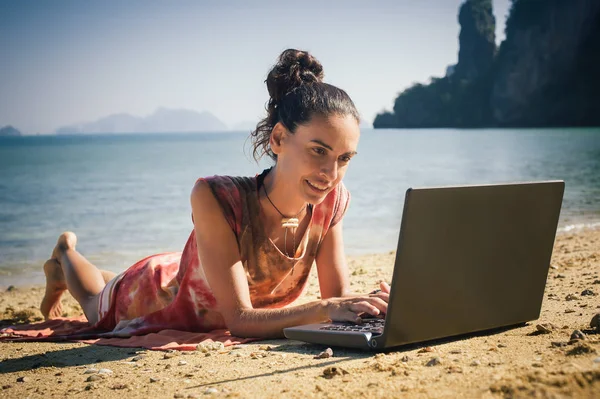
[0,129,600,287]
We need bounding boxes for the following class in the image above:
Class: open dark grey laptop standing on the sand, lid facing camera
[283,181,565,350]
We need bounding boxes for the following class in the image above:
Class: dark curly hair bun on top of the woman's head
[265,49,323,103]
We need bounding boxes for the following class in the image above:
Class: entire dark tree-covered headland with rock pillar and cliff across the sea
[373,0,600,128]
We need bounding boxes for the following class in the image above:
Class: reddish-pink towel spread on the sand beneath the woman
[0,316,258,351]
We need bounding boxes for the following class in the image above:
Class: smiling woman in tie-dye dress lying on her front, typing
[41,50,390,338]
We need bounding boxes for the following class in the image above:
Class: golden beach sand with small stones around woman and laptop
[0,230,600,398]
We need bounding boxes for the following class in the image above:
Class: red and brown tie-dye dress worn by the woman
[95,170,350,336]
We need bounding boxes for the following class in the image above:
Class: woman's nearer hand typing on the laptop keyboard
[325,283,390,323]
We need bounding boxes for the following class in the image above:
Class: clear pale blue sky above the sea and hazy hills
[0,0,510,134]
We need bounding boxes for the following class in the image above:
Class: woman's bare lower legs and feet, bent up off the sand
[40,232,115,324]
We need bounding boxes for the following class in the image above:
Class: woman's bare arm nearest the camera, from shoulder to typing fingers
[191,181,387,338]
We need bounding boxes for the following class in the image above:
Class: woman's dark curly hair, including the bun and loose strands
[250,49,360,162]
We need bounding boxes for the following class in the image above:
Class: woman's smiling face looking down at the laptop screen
[271,115,360,205]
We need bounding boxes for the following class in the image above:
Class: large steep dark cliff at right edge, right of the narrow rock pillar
[490,0,600,126]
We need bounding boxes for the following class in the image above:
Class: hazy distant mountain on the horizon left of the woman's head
[56,107,227,134]
